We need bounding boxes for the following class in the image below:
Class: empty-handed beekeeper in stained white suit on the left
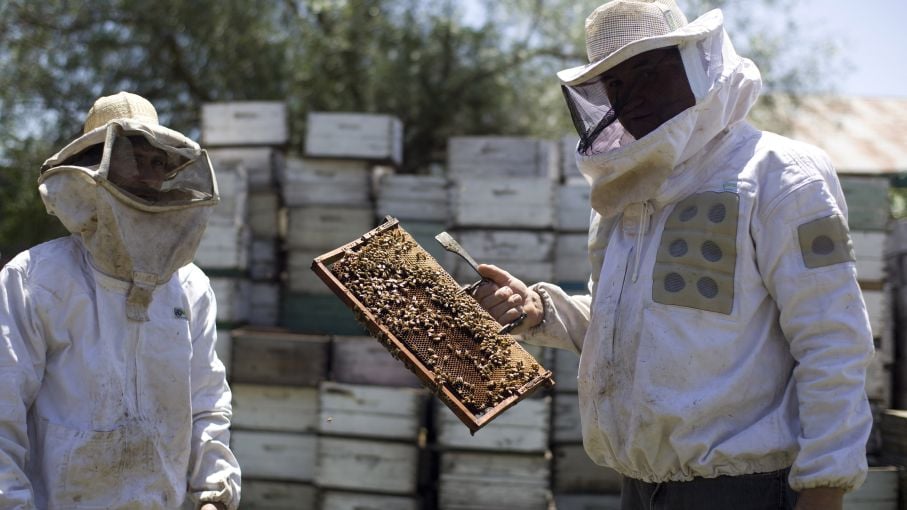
[0,92,240,510]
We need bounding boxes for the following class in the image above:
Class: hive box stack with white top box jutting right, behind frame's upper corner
[281,113,402,335]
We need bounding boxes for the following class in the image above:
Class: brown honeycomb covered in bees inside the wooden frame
[331,228,542,414]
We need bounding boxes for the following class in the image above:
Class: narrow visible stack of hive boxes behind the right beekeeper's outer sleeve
[840,175,895,409]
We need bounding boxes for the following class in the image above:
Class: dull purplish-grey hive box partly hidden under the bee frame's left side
[331,336,422,388]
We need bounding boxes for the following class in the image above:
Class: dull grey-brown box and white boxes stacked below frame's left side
[316,336,428,510]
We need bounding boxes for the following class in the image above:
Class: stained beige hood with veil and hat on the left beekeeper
[38,92,218,320]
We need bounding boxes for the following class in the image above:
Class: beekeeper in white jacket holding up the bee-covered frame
[476,0,873,510]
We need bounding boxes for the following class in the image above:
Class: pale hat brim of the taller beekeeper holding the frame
[557,9,724,86]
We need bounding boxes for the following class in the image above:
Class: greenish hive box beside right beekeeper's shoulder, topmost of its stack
[840,176,891,231]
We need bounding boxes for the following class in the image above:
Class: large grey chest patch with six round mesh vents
[652,191,739,314]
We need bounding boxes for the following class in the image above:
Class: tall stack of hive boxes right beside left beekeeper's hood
[195,101,287,366]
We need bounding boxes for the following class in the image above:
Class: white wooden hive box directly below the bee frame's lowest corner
[435,397,551,453]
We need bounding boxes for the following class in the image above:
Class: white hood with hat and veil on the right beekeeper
[558,0,762,218]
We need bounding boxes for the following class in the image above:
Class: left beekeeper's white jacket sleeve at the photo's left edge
[0,260,45,509]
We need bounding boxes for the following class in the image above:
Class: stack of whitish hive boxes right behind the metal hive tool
[446,137,558,283]
